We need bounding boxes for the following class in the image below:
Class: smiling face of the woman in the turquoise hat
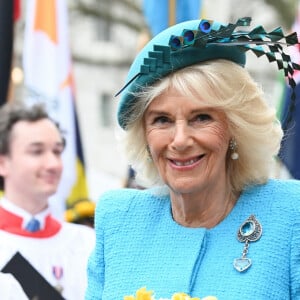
[144,90,230,194]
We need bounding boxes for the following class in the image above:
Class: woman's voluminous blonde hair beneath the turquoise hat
[123,59,283,192]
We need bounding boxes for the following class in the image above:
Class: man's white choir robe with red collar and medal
[0,207,95,300]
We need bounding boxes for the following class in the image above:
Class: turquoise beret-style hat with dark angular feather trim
[116,17,300,129]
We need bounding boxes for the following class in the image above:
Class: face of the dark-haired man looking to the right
[0,119,64,201]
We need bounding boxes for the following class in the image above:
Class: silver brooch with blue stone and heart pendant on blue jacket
[233,215,262,272]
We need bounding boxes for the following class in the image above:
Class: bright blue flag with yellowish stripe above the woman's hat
[143,0,202,36]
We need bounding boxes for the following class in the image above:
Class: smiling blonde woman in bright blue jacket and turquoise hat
[86,18,300,300]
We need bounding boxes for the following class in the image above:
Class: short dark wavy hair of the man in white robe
[0,102,65,189]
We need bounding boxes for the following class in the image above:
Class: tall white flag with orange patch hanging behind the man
[23,0,88,218]
